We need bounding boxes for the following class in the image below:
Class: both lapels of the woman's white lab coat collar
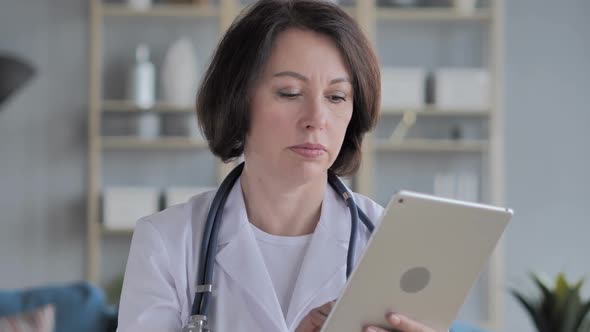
[216,179,350,331]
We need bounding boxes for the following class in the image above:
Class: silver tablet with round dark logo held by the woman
[321,191,512,332]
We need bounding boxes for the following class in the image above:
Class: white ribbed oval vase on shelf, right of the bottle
[160,37,199,107]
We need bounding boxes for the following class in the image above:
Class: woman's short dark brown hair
[196,0,381,176]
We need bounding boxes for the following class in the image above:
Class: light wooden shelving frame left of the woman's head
[86,0,239,294]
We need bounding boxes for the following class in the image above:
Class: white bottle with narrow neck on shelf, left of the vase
[127,44,156,108]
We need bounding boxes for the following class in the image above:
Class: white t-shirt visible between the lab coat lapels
[250,224,312,317]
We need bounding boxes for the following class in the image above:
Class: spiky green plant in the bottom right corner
[510,273,590,332]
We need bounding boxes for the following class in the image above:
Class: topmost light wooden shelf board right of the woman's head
[377,7,492,21]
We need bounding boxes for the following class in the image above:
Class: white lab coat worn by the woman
[117,180,383,332]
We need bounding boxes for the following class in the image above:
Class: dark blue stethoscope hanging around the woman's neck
[182,162,375,332]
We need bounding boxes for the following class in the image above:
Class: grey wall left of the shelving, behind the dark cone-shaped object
[0,0,88,287]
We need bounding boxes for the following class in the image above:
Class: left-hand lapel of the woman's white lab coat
[215,180,287,331]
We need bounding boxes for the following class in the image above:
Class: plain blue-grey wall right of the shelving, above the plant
[505,0,590,331]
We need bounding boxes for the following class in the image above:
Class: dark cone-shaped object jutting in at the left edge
[0,55,35,106]
